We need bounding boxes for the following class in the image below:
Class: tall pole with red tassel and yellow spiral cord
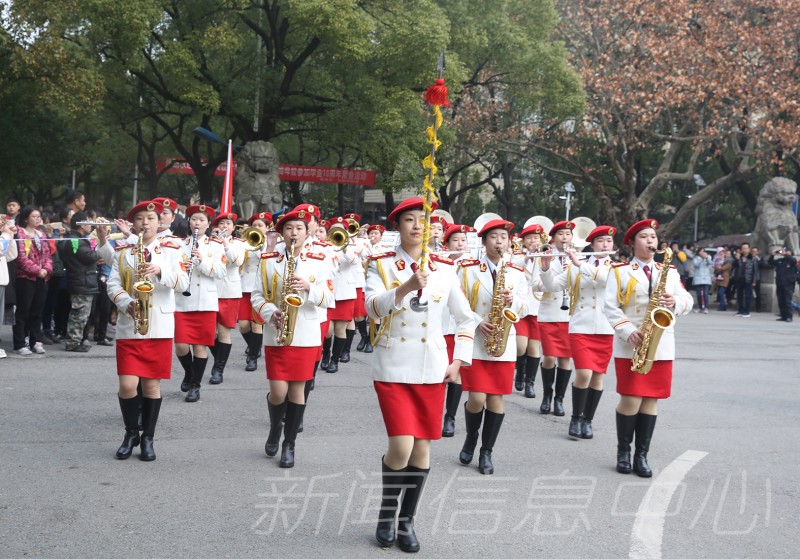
[410,51,450,312]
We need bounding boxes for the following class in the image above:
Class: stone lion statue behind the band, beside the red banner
[233,141,283,219]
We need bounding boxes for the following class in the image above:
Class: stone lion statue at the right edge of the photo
[753,177,800,254]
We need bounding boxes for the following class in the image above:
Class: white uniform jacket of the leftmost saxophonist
[105,237,189,340]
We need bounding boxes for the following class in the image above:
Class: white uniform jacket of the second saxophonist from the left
[250,247,333,347]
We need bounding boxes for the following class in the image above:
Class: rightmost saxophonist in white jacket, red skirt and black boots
[605,219,693,477]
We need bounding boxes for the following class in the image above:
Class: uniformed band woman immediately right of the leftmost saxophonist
[175,205,227,402]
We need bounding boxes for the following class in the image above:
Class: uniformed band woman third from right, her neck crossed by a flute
[534,221,575,417]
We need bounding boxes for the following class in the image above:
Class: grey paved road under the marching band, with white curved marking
[0,313,800,559]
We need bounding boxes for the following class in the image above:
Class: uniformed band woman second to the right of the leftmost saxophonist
[209,213,245,384]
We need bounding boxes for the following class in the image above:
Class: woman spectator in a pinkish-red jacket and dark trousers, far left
[14,206,53,355]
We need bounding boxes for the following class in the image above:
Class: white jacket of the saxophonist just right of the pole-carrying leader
[460,256,528,361]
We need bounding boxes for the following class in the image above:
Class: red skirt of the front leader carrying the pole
[374,381,445,441]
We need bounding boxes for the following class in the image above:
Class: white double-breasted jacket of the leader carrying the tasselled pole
[365,246,478,384]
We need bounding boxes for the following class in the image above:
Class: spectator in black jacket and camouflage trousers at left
[58,212,106,353]
